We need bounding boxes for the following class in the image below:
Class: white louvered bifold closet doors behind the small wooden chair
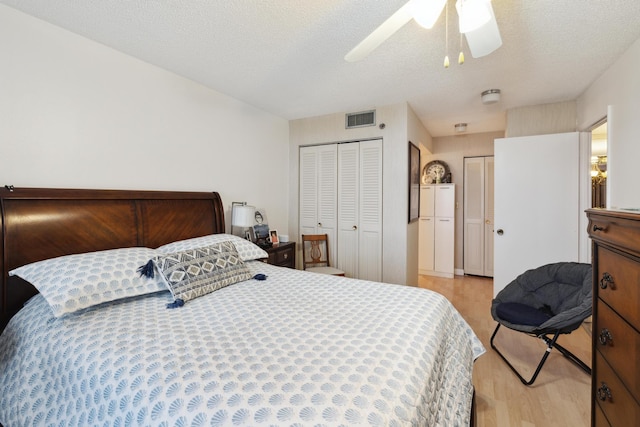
[299,139,382,281]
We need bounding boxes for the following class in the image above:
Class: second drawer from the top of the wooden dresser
[595,246,640,330]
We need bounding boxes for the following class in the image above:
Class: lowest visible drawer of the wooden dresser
[592,351,640,427]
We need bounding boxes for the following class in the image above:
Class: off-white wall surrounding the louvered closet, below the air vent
[289,103,418,285]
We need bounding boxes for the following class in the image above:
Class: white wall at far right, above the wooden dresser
[577,39,640,209]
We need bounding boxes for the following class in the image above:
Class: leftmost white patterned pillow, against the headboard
[9,247,167,317]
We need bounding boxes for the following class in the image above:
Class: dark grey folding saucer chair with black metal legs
[491,262,592,385]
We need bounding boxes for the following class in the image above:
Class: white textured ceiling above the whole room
[0,0,640,136]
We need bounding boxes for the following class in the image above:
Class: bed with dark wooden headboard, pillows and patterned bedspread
[0,187,485,427]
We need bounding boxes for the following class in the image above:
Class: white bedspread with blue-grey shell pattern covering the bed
[0,261,485,427]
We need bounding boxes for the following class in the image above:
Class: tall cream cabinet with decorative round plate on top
[418,184,456,277]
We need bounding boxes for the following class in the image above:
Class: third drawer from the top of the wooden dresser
[593,300,640,402]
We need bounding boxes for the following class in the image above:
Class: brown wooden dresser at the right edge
[587,209,640,427]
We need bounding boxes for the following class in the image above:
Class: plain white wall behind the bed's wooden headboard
[0,5,289,230]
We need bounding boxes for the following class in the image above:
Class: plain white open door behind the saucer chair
[493,132,580,295]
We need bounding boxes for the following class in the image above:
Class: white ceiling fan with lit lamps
[344,0,502,62]
